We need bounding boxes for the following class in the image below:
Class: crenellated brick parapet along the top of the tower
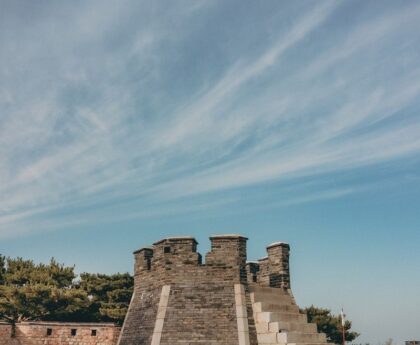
[134,234,290,288]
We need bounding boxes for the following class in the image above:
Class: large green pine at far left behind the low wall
[0,256,90,329]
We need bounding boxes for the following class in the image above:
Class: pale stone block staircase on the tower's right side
[250,286,327,345]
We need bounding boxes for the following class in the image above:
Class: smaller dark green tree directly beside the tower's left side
[79,273,134,325]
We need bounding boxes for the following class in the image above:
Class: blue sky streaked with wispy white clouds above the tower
[0,0,420,345]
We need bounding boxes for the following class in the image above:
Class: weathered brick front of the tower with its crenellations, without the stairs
[120,235,247,345]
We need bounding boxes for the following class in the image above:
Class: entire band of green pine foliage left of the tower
[0,255,133,325]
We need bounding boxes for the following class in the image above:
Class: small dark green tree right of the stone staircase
[301,305,360,344]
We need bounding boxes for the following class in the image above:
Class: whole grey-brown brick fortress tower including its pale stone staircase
[118,235,326,345]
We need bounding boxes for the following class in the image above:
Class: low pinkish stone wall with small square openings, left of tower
[0,322,120,345]
